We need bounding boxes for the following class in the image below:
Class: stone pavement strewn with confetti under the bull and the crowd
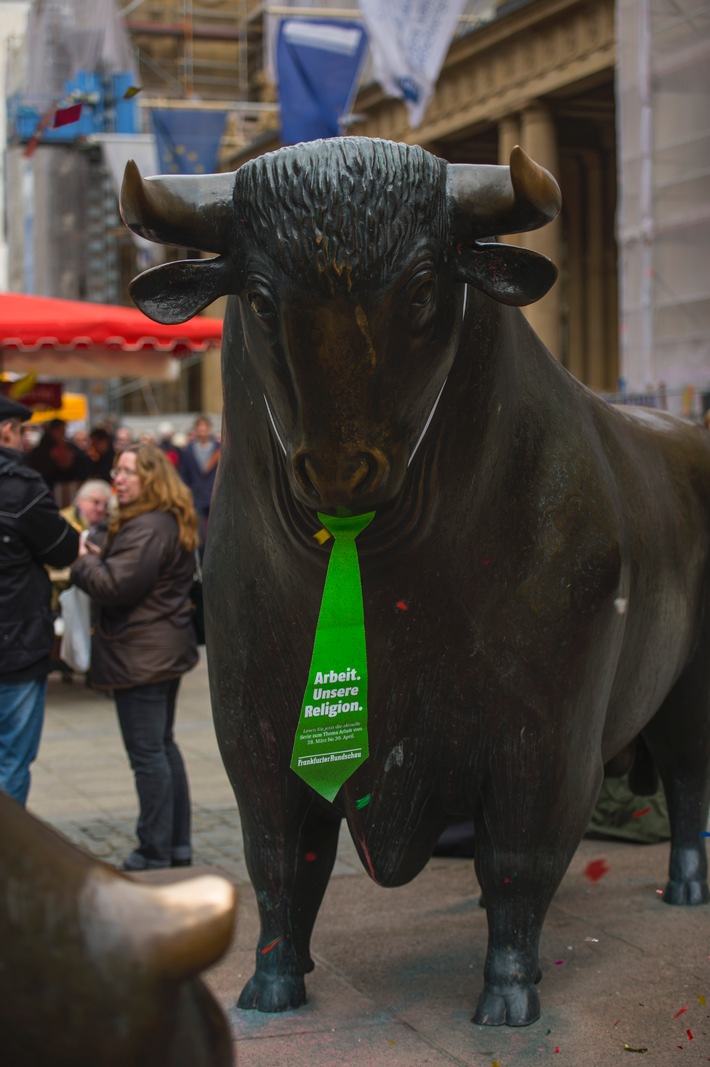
[29,663,710,1067]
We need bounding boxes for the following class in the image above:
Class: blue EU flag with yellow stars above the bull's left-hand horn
[152,108,226,174]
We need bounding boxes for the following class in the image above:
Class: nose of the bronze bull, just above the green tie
[294,449,389,505]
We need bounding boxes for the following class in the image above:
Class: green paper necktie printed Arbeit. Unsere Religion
[290,511,375,801]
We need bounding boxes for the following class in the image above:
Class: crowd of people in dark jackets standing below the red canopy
[0,396,220,871]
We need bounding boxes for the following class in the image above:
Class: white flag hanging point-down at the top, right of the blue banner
[360,0,467,128]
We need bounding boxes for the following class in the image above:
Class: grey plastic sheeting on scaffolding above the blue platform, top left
[25,0,136,107]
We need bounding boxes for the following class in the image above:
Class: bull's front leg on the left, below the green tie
[237,798,341,1012]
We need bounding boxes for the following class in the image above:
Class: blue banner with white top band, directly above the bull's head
[277,18,367,144]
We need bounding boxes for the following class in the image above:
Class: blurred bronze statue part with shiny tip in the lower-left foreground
[0,793,236,1067]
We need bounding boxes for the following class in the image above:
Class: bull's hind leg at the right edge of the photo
[644,661,710,904]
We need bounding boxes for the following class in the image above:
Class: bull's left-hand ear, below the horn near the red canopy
[128,256,234,325]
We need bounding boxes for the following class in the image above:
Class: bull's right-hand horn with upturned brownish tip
[447,145,562,239]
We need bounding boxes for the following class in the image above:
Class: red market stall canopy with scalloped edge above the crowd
[0,292,222,381]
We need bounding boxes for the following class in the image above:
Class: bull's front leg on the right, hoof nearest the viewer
[473,752,602,1026]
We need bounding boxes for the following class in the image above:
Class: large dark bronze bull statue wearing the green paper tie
[123,138,710,1025]
